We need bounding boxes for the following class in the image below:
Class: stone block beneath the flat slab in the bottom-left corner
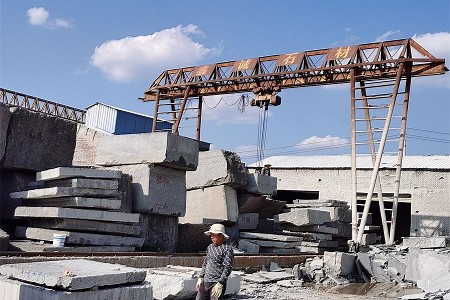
[0,276,153,300]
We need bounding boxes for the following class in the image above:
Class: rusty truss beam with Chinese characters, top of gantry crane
[143,39,448,101]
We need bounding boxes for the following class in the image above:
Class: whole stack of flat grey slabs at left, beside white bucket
[10,167,145,250]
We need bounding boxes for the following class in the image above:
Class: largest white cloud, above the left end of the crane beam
[91,24,220,81]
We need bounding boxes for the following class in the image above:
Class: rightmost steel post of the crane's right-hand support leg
[387,76,411,245]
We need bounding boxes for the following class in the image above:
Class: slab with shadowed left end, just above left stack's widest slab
[22,197,122,209]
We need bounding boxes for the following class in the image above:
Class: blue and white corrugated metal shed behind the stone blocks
[85,102,172,135]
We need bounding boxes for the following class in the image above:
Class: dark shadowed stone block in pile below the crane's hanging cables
[237,194,286,219]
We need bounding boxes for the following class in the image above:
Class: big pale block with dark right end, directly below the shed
[95,132,199,171]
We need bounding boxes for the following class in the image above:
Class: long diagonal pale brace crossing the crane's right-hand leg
[357,62,405,244]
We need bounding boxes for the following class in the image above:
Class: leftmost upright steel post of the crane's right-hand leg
[350,68,358,242]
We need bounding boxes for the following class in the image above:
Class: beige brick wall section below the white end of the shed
[72,124,112,167]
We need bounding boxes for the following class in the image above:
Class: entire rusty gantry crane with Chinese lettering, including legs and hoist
[143,39,448,248]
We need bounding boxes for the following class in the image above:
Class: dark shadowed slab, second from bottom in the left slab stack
[28,218,141,236]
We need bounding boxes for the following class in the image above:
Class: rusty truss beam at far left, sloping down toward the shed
[0,88,86,124]
